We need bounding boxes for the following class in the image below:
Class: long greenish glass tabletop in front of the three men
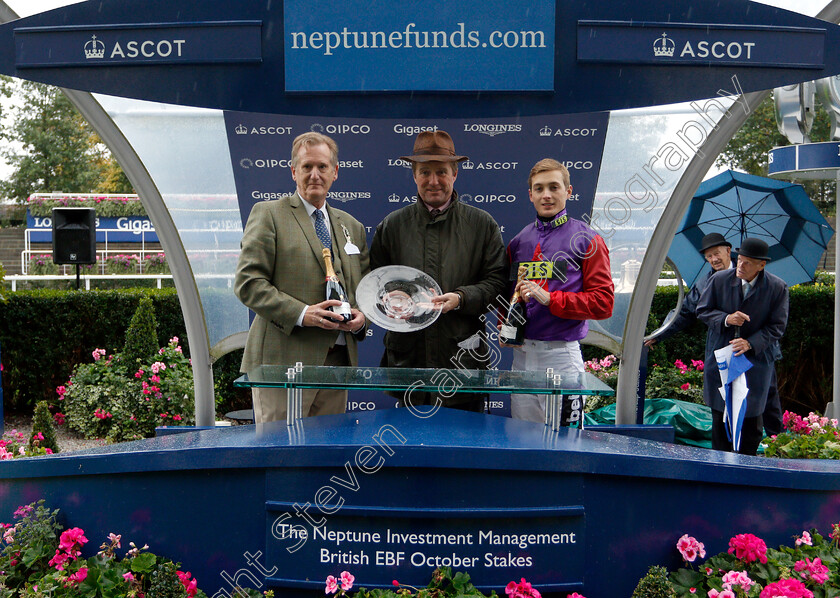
[233,365,615,395]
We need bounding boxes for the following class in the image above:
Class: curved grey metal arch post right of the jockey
[615,0,840,425]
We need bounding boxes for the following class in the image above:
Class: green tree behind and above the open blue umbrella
[716,97,835,213]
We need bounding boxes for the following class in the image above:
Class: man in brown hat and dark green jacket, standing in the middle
[370,131,507,411]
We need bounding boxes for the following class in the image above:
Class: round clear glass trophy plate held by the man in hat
[356,266,442,332]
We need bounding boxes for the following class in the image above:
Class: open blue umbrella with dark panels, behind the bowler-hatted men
[668,170,834,286]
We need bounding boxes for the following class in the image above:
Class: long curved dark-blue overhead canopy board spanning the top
[0,0,840,119]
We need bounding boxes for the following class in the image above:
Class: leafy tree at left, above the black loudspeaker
[0,79,131,203]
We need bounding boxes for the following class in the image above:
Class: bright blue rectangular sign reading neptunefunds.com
[284,0,554,92]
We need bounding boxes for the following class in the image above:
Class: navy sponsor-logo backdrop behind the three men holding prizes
[225,112,608,414]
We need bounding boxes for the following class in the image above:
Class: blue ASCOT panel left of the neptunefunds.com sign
[15,21,262,68]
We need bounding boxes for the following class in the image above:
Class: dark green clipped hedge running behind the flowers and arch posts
[0,285,834,415]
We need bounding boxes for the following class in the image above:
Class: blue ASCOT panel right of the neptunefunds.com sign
[578,21,825,68]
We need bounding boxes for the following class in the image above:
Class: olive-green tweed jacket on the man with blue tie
[234,193,369,372]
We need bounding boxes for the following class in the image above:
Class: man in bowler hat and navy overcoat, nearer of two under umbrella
[697,238,788,455]
